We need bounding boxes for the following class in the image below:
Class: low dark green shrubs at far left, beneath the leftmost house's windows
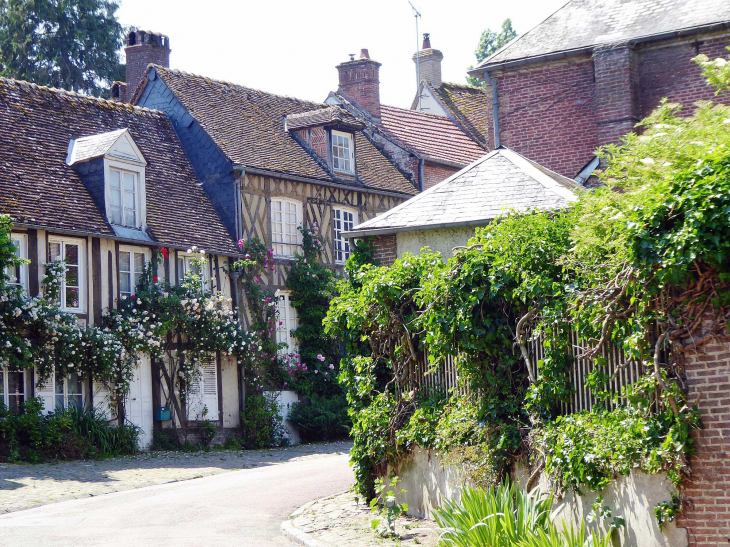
[0,399,139,463]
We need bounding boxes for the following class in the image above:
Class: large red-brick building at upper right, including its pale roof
[470,0,730,181]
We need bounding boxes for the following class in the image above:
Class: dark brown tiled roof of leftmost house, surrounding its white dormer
[0,78,237,254]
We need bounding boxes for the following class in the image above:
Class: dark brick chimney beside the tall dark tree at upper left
[118,30,170,102]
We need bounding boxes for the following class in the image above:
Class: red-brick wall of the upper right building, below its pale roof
[486,30,730,178]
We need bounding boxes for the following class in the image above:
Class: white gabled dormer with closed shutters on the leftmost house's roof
[66,129,152,241]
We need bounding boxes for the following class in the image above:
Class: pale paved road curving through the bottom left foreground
[0,455,353,547]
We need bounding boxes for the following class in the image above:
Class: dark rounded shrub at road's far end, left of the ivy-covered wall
[289,395,351,441]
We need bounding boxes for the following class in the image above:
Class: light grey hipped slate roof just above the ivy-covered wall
[348,148,581,236]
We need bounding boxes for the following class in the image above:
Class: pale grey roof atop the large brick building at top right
[474,0,730,71]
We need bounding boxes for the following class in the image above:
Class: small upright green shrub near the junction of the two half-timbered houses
[241,393,287,449]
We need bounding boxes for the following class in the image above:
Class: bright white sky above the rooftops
[117,0,566,108]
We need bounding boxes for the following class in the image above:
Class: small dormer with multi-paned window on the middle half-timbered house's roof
[284,106,365,179]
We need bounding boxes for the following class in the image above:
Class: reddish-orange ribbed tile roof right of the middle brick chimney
[379,105,485,165]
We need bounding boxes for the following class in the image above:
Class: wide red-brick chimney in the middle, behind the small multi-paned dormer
[337,49,380,122]
